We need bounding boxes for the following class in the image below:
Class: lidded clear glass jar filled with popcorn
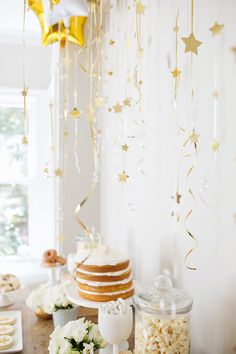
[134,275,193,354]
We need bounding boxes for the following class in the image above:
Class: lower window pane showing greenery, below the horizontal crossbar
[0,184,28,256]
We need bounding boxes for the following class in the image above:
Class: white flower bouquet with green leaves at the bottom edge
[48,318,105,354]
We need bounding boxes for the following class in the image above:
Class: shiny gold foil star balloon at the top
[28,0,87,46]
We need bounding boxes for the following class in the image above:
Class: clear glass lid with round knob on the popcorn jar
[134,275,193,316]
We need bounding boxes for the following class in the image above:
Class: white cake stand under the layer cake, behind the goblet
[66,282,133,354]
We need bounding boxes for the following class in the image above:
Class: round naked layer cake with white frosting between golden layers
[76,248,134,302]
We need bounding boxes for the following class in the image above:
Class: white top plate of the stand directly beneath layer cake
[66,282,133,309]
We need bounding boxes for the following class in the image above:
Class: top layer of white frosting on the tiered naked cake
[75,247,129,266]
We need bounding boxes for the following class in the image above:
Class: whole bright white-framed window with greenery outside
[0,92,54,260]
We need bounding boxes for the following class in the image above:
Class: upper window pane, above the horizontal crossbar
[0,107,27,181]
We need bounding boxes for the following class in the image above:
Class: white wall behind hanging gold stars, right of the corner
[101,0,236,354]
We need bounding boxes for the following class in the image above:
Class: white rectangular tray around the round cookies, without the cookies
[0,311,23,354]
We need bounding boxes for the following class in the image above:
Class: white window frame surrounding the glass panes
[0,88,55,263]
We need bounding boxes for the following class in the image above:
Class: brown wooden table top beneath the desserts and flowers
[1,301,134,354]
